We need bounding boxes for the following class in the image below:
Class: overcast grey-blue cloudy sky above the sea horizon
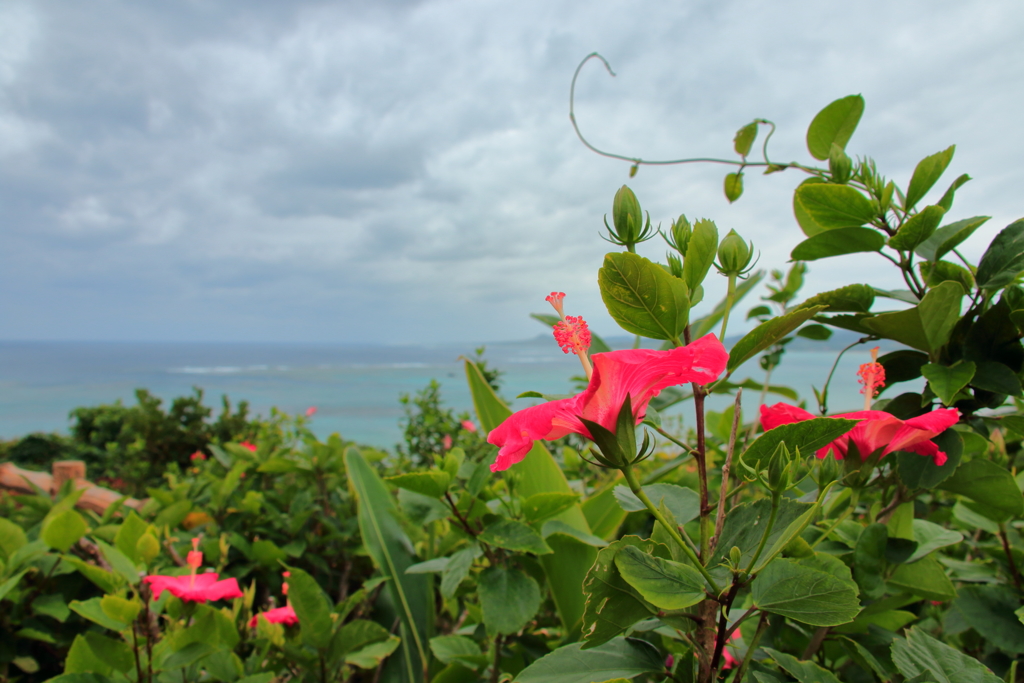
[6,0,1024,343]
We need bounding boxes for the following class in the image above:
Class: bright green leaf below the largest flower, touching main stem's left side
[615,546,705,609]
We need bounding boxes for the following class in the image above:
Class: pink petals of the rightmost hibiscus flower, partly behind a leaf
[761,403,959,465]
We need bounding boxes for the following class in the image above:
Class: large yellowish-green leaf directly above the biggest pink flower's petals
[597,252,690,340]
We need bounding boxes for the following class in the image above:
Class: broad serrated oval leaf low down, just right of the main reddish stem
[751,559,860,626]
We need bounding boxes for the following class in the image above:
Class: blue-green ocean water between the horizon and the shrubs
[0,336,880,449]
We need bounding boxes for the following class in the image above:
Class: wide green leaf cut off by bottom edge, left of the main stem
[515,638,665,683]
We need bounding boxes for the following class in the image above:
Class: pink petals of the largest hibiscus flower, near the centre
[487,334,729,472]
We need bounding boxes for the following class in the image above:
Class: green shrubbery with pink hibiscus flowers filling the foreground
[6,73,1024,683]
